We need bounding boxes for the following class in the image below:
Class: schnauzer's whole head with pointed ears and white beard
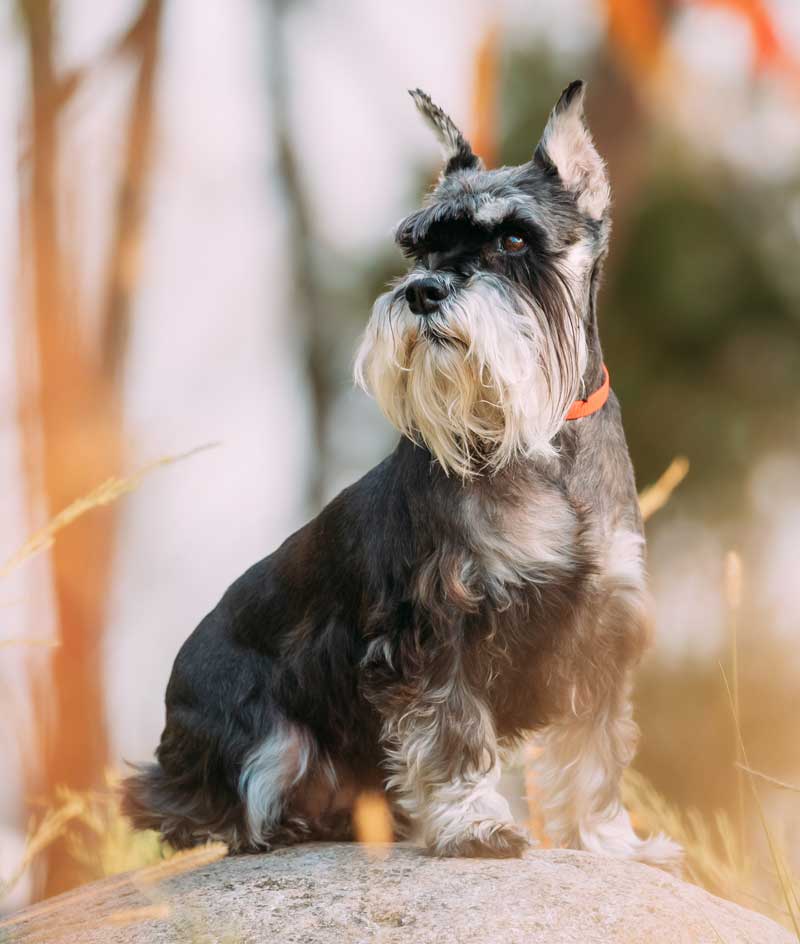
[356,82,610,477]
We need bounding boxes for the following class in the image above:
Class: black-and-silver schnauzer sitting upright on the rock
[123,81,680,866]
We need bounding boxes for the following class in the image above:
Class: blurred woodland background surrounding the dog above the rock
[0,0,800,919]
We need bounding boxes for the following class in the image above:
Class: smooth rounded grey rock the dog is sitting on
[0,843,793,944]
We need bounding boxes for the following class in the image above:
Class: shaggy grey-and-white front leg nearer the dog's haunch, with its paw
[382,674,529,858]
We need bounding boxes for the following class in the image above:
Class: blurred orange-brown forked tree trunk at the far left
[18,0,162,895]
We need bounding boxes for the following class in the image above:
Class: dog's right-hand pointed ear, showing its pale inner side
[533,80,611,220]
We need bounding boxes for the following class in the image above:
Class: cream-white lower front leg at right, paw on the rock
[536,700,682,868]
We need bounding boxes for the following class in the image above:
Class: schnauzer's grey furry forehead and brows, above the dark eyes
[397,166,563,245]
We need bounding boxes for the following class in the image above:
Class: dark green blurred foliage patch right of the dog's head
[602,184,800,508]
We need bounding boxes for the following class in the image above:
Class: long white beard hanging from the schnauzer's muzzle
[355,275,587,478]
